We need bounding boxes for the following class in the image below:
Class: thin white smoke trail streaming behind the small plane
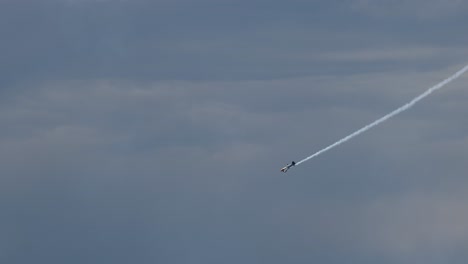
[296,65,468,165]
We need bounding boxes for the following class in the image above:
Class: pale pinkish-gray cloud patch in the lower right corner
[363,191,468,259]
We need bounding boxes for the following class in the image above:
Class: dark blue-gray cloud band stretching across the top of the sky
[0,0,466,85]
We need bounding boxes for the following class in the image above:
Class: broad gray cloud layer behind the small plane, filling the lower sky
[0,64,467,263]
